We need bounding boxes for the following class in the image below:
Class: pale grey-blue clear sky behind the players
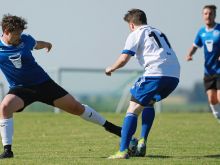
[0,0,220,89]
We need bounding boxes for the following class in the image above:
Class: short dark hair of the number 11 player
[124,9,147,25]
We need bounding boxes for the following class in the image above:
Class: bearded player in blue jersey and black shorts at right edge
[186,5,220,120]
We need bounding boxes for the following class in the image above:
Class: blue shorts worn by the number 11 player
[130,76,179,106]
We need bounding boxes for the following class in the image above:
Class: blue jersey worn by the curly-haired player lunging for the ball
[0,34,50,88]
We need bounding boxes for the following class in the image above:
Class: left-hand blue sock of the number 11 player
[120,113,138,151]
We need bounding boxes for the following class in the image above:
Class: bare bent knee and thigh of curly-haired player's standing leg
[0,94,24,118]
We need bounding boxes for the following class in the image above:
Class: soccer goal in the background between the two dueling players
[54,67,162,113]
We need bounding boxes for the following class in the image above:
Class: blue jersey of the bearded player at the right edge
[194,24,220,75]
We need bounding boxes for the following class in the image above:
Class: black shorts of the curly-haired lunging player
[8,79,68,112]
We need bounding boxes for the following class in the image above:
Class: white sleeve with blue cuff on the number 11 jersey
[122,33,138,56]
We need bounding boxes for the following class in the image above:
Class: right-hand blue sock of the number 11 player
[140,106,155,141]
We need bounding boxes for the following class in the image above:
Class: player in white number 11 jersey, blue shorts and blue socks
[105,9,180,159]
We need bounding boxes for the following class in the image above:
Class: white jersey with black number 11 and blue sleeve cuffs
[122,25,180,78]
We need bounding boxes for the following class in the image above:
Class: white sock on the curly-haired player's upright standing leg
[0,118,14,146]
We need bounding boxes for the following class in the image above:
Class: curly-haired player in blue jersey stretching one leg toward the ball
[0,14,121,159]
